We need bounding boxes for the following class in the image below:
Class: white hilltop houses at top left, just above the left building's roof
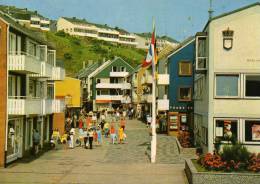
[0,5,50,31]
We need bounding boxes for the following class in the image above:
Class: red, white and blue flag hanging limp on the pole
[142,23,157,72]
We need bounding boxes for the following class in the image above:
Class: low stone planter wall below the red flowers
[184,159,260,184]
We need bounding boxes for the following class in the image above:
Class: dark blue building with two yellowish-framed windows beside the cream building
[167,37,195,135]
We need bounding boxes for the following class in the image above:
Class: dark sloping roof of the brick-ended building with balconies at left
[0,11,54,49]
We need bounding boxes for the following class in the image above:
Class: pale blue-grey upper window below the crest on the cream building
[216,75,239,97]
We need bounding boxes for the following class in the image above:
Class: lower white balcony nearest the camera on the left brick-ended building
[8,97,42,115]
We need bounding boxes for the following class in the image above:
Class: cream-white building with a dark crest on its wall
[194,3,260,152]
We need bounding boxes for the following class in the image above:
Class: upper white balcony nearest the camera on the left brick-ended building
[8,53,41,74]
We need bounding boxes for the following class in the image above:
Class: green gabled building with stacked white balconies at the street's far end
[87,57,134,111]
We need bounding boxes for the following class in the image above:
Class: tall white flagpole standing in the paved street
[151,19,156,163]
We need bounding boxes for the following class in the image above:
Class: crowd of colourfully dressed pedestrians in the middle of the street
[52,110,126,149]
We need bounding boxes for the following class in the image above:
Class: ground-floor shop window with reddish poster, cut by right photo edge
[245,120,260,142]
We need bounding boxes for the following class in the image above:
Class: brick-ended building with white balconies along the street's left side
[0,13,65,166]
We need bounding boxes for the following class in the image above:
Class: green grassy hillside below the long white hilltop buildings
[42,32,145,76]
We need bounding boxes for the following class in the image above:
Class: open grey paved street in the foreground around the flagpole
[0,120,186,184]
